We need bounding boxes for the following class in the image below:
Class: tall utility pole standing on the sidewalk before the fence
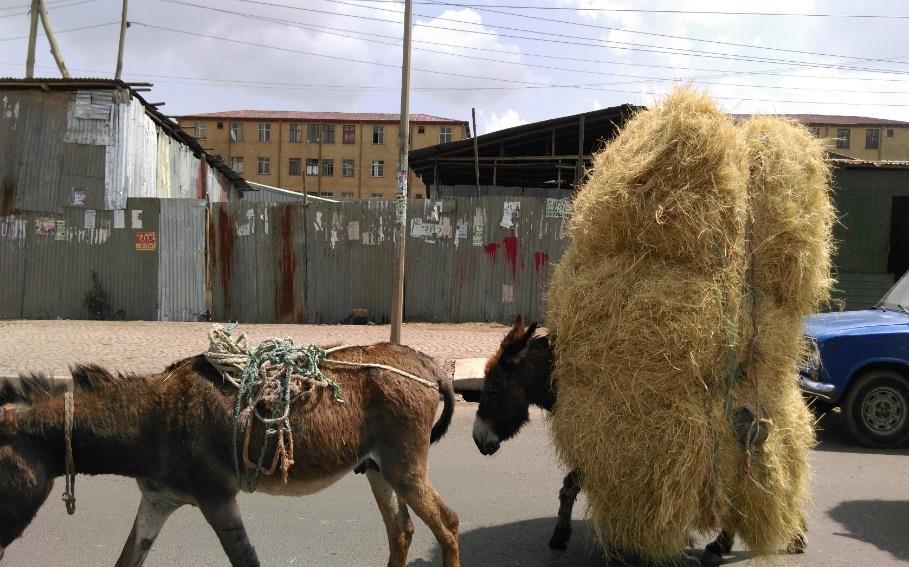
[391,0,413,344]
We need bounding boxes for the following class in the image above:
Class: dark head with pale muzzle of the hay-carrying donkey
[473,315,551,455]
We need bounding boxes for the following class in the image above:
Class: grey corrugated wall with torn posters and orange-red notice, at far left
[0,199,205,321]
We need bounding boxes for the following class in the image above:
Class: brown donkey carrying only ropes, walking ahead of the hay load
[0,343,460,567]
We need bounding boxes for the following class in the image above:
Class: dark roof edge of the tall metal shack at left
[0,77,249,190]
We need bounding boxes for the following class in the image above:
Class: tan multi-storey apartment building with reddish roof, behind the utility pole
[178,110,470,200]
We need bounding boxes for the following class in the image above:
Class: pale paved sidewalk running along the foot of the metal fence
[0,320,508,389]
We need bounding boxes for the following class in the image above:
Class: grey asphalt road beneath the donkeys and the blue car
[0,403,909,567]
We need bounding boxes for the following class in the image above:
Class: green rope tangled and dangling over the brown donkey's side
[216,325,346,492]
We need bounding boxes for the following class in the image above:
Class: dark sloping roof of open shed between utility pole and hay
[408,104,643,188]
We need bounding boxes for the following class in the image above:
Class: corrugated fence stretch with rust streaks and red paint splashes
[209,197,567,323]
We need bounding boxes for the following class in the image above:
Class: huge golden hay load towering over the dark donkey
[547,90,832,560]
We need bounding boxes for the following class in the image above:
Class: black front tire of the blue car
[843,370,909,449]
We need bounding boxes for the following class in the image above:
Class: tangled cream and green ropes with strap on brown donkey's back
[205,323,438,492]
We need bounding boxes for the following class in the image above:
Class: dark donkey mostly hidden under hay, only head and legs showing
[473,316,805,563]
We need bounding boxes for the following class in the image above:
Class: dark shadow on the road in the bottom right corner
[827,500,909,562]
